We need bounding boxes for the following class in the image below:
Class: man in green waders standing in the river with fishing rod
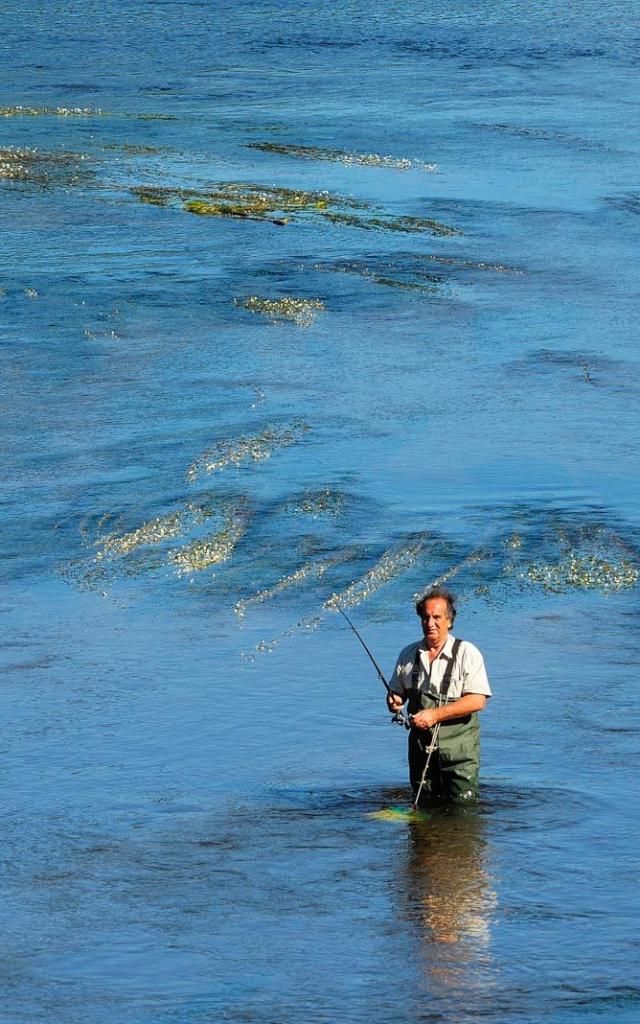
[387,588,492,803]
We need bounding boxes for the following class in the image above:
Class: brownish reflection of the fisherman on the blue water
[407,808,496,981]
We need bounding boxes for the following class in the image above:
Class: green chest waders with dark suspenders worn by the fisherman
[409,640,480,803]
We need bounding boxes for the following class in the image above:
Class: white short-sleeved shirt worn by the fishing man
[389,633,492,700]
